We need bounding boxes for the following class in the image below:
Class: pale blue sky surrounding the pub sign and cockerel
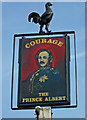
[2,2,85,118]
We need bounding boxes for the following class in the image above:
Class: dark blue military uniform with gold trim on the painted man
[22,67,66,97]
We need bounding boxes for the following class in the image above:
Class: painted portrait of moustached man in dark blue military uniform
[21,49,66,97]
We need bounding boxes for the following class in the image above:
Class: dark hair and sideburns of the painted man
[35,49,53,65]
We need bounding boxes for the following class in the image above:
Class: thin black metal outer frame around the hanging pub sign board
[11,31,77,110]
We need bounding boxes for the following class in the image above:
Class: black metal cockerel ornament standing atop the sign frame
[28,2,53,33]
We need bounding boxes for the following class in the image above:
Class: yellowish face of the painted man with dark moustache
[38,51,49,67]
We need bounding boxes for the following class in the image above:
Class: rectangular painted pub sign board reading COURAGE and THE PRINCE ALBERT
[18,36,70,108]
